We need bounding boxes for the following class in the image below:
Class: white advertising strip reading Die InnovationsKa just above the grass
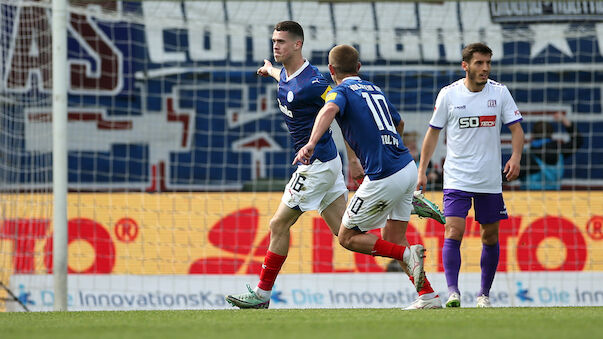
[7,272,603,311]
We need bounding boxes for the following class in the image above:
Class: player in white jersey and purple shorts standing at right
[417,43,524,307]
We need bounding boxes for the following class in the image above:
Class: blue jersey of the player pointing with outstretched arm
[277,60,337,162]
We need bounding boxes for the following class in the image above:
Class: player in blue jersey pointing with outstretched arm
[226,21,357,308]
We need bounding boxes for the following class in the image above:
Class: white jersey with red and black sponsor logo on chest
[429,79,522,193]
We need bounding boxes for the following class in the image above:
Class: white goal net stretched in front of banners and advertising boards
[0,0,603,311]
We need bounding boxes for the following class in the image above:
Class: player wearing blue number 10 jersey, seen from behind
[294,45,442,309]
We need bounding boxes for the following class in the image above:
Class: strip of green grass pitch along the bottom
[0,307,603,339]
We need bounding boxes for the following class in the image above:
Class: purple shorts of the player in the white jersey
[444,189,508,225]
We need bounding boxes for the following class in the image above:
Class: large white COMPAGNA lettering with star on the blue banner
[142,1,603,63]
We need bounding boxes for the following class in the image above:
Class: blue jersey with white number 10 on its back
[326,77,413,180]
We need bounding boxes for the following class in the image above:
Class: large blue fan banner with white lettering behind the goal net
[0,1,603,192]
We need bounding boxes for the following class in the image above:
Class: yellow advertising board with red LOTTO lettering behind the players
[0,192,603,275]
